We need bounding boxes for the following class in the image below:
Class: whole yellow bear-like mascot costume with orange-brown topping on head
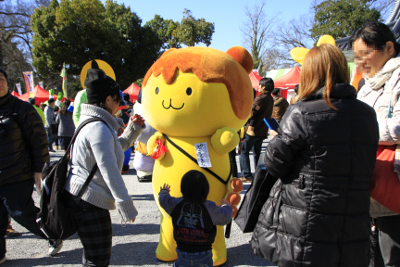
[142,46,253,266]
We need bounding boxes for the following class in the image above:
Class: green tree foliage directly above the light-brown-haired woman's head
[311,0,380,39]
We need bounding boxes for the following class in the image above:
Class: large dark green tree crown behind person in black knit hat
[31,0,162,89]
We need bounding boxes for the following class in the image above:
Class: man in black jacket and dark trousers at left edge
[0,68,62,263]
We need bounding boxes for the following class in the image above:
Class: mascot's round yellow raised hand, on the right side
[211,127,239,155]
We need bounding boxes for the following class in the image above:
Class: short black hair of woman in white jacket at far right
[350,22,400,56]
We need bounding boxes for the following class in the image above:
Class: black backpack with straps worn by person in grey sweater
[36,118,103,240]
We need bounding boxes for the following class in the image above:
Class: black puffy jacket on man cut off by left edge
[0,93,49,186]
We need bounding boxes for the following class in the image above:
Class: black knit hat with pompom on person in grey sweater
[84,60,119,104]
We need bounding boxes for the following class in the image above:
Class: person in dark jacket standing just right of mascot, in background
[239,78,274,182]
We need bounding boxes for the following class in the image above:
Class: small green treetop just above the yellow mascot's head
[146,9,214,50]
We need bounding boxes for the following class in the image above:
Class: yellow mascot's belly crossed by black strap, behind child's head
[153,136,231,217]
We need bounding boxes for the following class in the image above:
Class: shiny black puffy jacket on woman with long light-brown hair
[251,84,379,267]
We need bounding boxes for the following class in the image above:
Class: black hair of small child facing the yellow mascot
[181,170,210,203]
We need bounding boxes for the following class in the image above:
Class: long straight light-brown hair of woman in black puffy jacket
[297,44,350,109]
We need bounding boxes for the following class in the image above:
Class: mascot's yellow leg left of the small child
[156,214,178,261]
